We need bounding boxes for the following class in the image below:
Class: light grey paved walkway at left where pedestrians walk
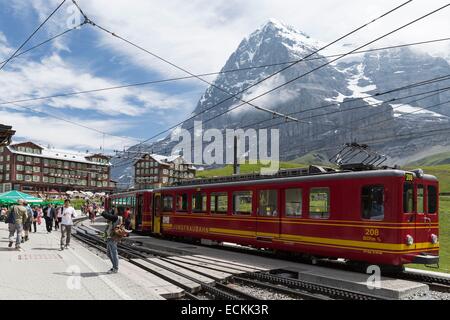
[0,223,163,300]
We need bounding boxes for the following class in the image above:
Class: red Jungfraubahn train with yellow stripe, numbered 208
[107,167,439,266]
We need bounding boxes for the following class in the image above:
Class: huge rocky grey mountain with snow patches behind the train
[111,19,450,185]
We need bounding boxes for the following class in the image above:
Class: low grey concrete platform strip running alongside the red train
[84,219,429,300]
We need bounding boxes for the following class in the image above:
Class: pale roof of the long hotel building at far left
[7,142,111,166]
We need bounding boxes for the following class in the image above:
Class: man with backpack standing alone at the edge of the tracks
[102,209,128,273]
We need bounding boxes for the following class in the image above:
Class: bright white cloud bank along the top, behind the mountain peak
[30,0,450,75]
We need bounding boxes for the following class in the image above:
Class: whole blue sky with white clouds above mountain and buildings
[0,0,450,151]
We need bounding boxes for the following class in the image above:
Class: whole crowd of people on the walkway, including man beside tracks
[0,200,131,273]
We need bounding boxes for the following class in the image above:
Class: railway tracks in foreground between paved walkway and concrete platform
[74,221,386,300]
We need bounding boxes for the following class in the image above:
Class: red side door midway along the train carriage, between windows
[256,189,281,243]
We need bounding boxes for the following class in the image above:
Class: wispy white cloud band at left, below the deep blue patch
[0,54,192,116]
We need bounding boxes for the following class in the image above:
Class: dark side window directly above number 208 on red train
[361,186,384,221]
